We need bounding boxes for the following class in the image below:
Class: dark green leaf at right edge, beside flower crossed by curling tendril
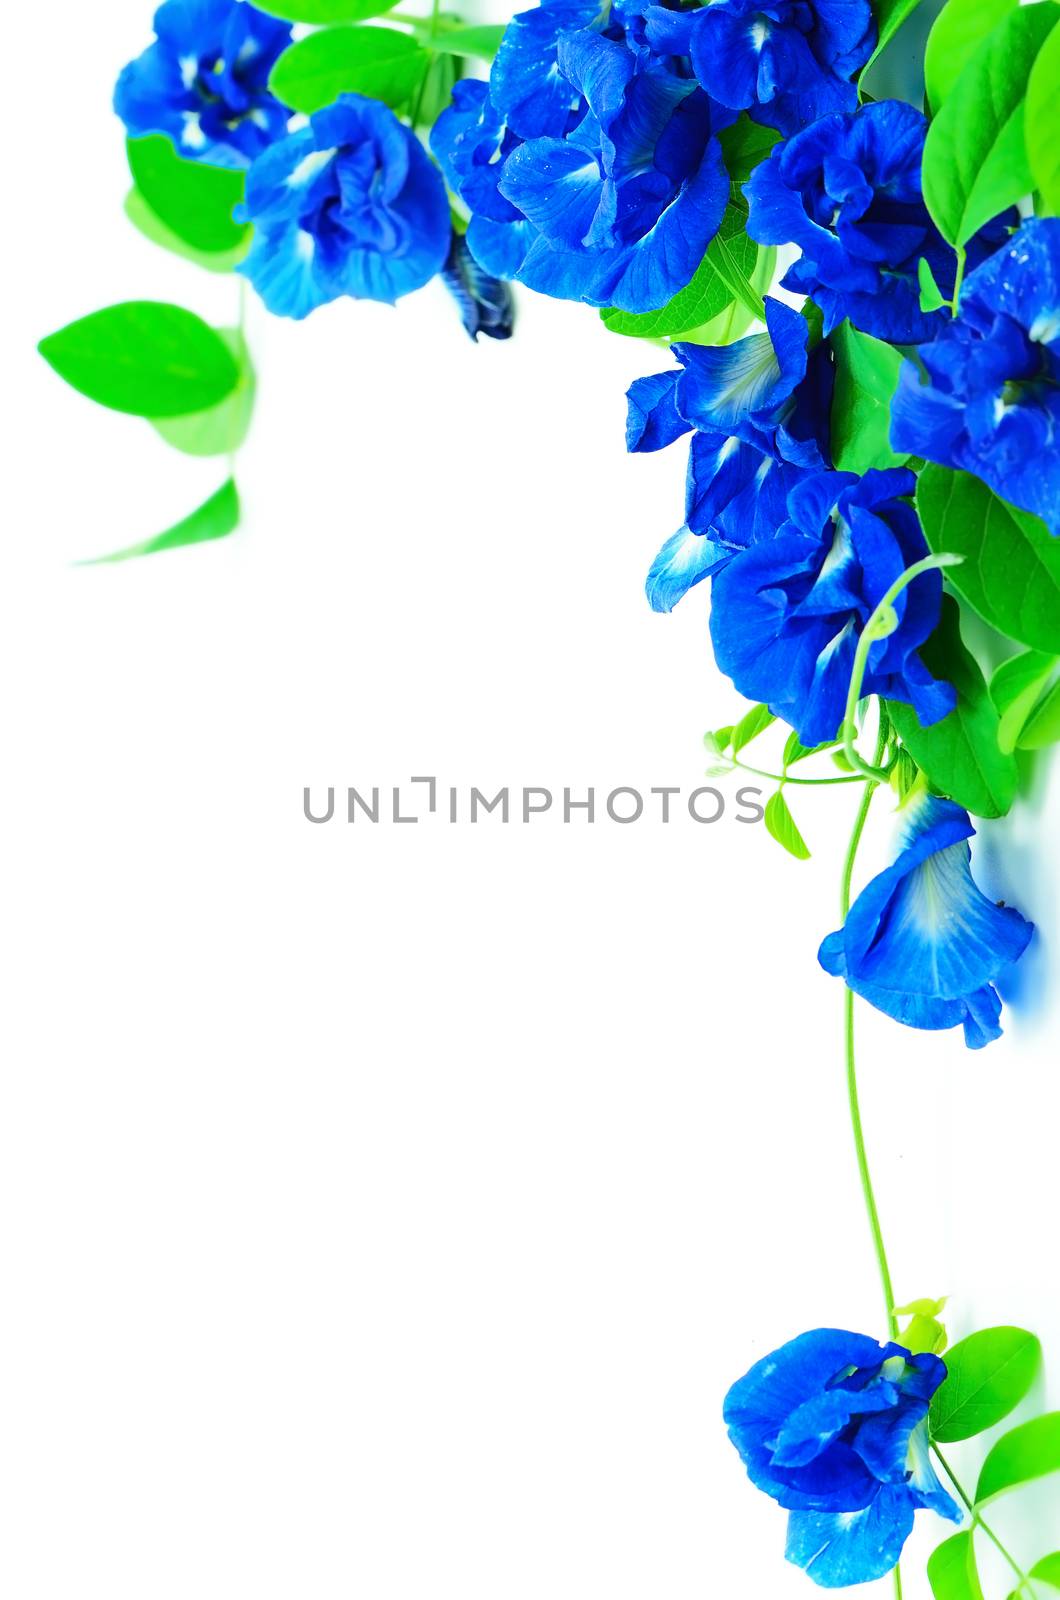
[916,466,1060,654]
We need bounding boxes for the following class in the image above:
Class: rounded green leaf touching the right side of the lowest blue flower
[930,1328,1042,1445]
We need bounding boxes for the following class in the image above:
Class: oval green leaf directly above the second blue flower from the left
[269,26,431,112]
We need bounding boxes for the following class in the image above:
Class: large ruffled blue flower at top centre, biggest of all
[431,0,735,312]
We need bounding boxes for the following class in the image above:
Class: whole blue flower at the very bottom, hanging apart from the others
[725,1328,961,1589]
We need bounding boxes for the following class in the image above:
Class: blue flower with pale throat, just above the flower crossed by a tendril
[626,299,833,611]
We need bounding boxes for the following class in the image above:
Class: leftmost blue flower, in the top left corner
[114,0,291,166]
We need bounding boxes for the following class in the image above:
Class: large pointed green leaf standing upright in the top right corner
[924,0,1060,246]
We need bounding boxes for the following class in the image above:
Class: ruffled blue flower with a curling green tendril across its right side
[711,469,956,747]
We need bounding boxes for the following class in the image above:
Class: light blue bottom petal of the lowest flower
[785,1485,914,1589]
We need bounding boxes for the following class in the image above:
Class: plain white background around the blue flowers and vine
[0,0,1060,1600]
